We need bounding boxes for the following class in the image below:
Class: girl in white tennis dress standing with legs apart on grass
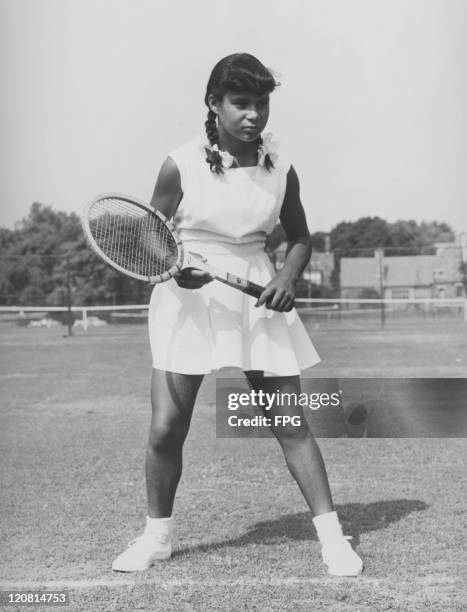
[112,53,362,576]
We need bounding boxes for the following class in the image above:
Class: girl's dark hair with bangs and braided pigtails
[204,53,279,174]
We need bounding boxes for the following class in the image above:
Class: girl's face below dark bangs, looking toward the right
[208,91,269,142]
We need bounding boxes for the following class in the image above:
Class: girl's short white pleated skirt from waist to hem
[148,241,320,376]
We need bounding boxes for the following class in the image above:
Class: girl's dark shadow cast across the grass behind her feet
[174,499,428,557]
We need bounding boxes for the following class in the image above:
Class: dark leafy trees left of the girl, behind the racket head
[0,202,149,306]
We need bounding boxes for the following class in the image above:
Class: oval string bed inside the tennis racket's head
[89,198,178,277]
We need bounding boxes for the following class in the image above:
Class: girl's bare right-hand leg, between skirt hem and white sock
[245,372,334,516]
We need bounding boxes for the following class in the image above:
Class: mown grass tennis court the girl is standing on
[0,321,467,612]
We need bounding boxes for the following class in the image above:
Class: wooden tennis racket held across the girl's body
[82,193,264,298]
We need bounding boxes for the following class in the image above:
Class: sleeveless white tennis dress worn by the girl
[149,136,320,376]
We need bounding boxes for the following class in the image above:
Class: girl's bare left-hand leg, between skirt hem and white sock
[146,369,203,518]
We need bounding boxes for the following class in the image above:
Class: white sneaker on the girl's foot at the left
[112,533,172,572]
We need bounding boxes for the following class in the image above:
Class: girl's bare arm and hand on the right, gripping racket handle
[257,166,311,312]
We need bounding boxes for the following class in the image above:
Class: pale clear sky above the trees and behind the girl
[0,0,467,231]
